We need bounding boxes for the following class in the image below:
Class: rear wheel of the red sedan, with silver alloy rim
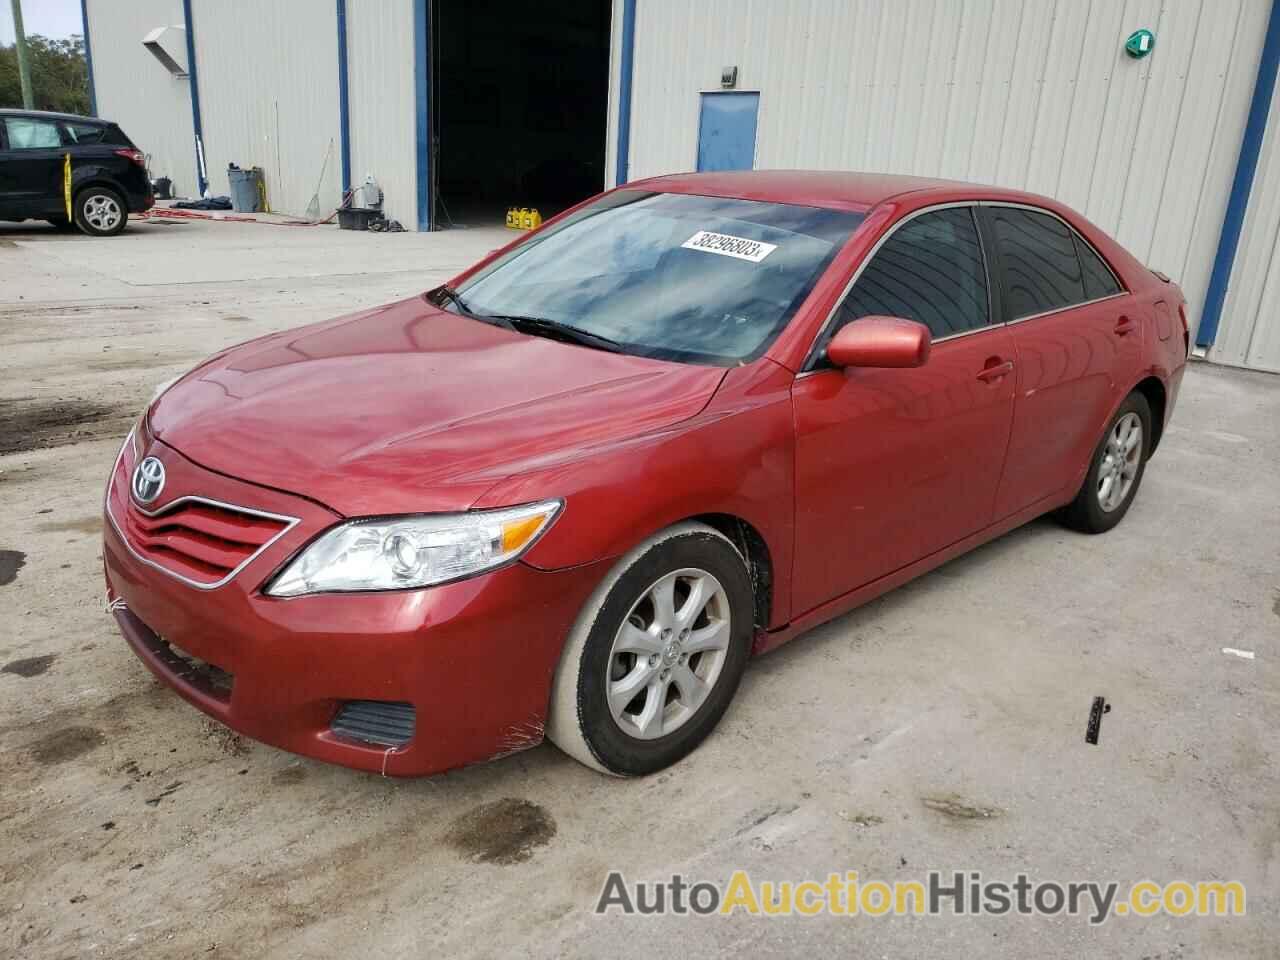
[1057,393,1151,534]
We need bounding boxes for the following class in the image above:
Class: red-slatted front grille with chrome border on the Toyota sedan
[106,451,297,589]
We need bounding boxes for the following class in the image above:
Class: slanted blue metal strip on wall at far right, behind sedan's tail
[1196,0,1280,347]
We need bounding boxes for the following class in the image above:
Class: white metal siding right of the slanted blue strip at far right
[1210,71,1280,372]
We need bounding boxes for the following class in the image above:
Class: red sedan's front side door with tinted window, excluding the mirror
[792,206,1014,614]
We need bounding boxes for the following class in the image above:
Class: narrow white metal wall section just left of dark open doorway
[345,0,417,230]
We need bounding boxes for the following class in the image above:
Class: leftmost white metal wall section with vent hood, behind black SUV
[87,0,196,196]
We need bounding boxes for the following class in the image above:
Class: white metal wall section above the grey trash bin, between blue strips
[189,0,342,215]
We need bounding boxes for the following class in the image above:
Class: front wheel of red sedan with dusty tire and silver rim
[547,522,754,777]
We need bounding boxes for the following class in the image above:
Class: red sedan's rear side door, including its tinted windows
[982,204,1146,518]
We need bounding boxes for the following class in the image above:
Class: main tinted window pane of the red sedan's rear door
[992,207,1088,320]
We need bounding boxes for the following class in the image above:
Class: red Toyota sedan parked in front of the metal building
[104,172,1188,776]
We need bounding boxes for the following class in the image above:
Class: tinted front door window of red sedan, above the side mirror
[836,207,991,339]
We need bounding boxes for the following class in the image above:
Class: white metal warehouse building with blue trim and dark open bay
[82,0,1280,371]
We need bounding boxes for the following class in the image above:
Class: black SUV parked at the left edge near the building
[0,110,155,237]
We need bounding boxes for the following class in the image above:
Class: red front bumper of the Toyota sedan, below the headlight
[102,443,607,776]
